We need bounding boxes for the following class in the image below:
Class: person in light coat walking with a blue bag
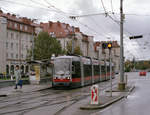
[15,65,22,89]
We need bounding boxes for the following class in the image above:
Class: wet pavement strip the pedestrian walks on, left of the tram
[0,83,52,97]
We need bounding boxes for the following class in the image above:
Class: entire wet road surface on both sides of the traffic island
[0,73,150,115]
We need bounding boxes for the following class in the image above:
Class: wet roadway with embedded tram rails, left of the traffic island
[0,75,117,115]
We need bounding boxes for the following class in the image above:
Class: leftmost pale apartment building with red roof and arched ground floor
[0,10,40,74]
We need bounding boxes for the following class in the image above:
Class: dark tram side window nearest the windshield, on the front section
[72,61,81,78]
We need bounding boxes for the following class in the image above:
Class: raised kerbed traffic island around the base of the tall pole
[80,85,135,110]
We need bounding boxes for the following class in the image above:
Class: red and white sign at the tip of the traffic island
[91,85,99,104]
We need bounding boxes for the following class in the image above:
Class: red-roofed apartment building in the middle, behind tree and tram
[40,21,94,57]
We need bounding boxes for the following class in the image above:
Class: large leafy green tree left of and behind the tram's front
[29,32,62,60]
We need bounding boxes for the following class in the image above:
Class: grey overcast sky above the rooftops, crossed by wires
[0,0,150,59]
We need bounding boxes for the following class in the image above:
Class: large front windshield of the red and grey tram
[54,59,71,75]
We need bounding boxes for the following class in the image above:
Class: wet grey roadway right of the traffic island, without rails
[91,73,150,115]
